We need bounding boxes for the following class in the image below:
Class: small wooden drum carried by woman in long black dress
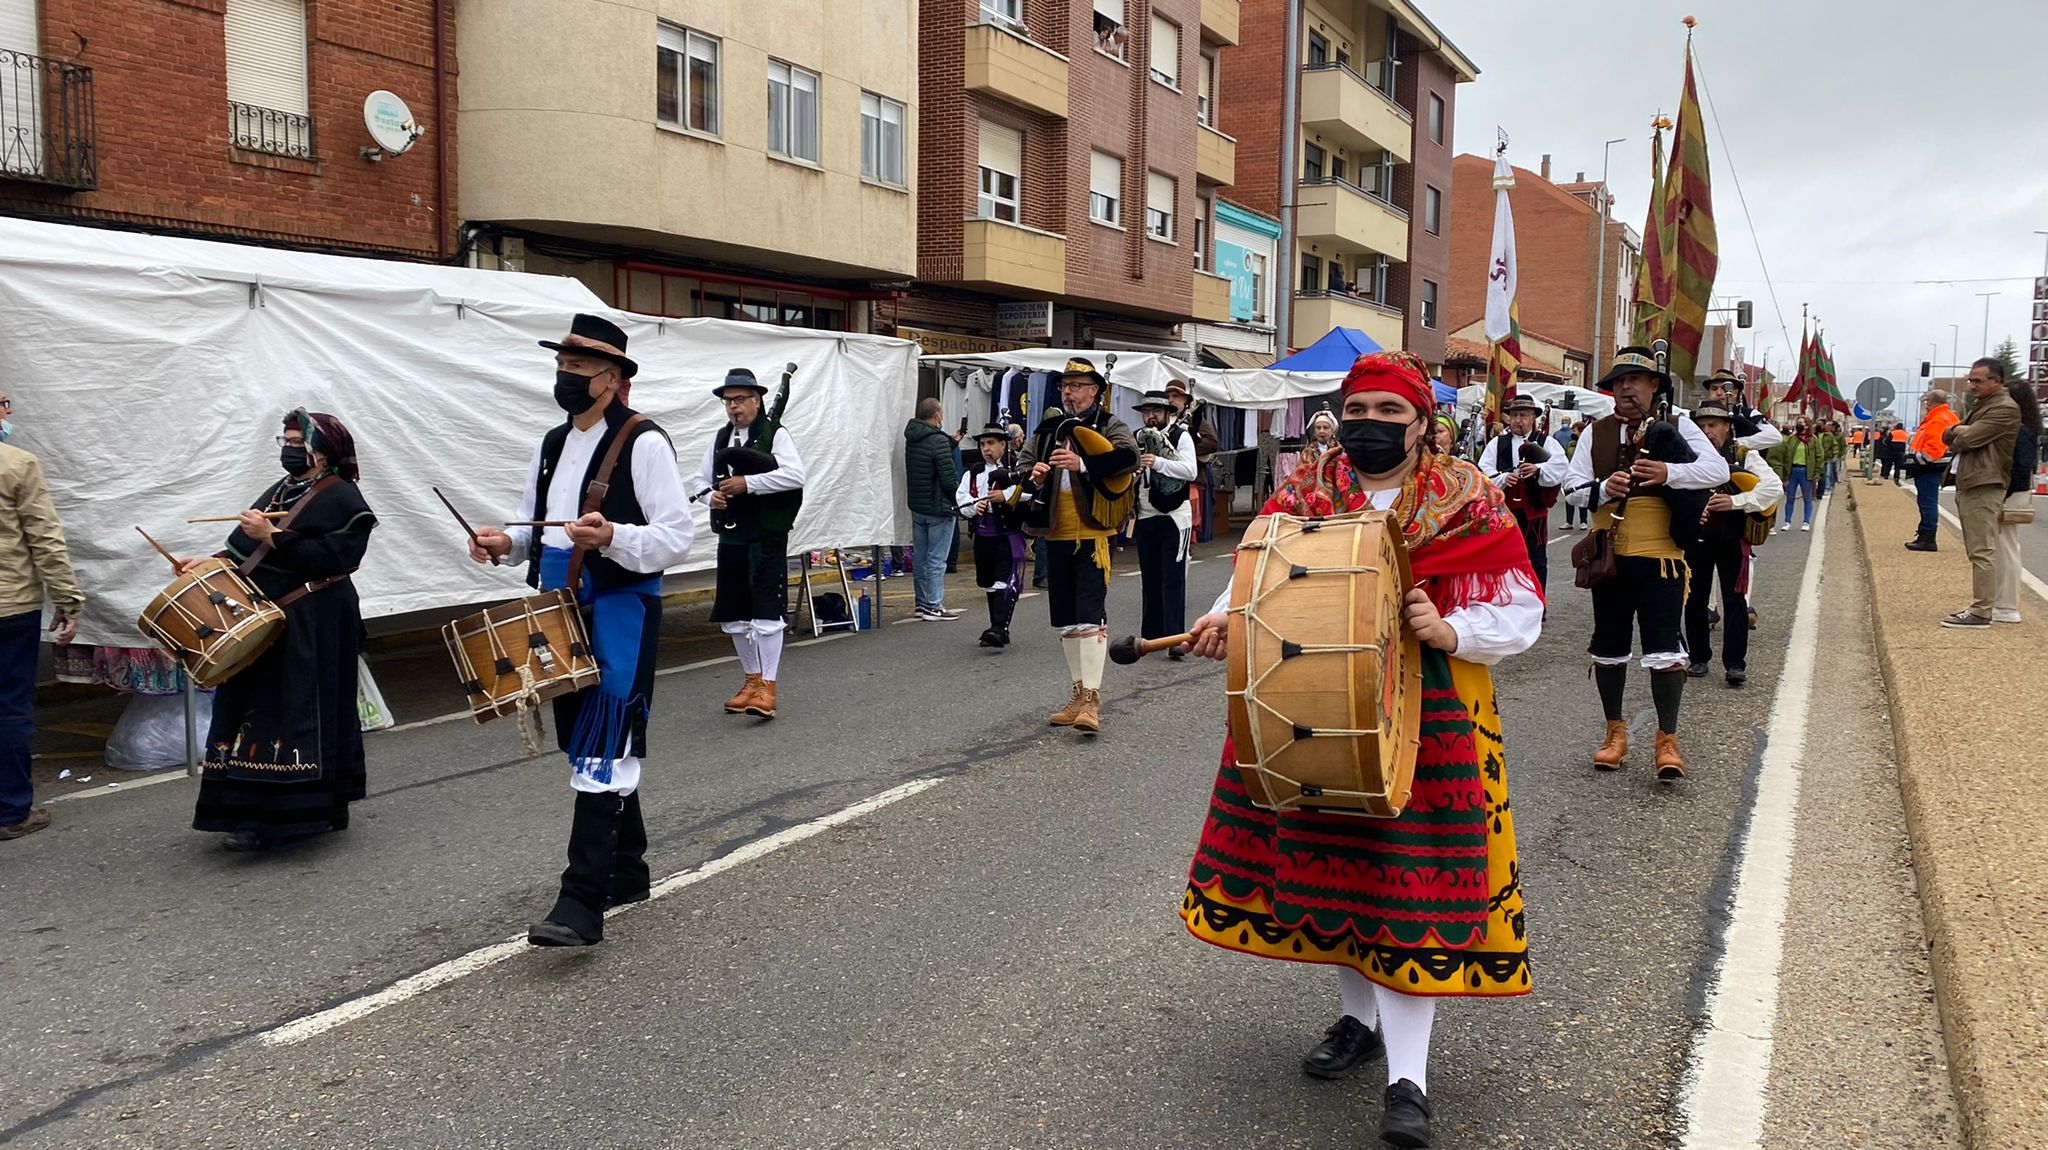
[135,559,285,690]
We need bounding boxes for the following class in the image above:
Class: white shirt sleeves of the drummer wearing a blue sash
[506,422,694,575]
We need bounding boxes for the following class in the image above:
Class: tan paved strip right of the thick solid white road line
[1843,483,2048,1150]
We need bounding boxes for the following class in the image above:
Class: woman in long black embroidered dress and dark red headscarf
[178,407,377,851]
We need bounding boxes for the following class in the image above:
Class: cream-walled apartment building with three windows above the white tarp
[457,0,920,331]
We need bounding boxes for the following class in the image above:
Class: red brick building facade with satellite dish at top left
[0,0,459,260]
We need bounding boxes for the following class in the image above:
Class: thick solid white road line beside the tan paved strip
[1679,503,1827,1150]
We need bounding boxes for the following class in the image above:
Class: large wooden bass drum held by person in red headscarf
[1225,512,1421,819]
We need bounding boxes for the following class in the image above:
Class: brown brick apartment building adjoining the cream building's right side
[881,0,1239,354]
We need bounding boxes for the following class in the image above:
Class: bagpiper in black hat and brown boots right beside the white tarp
[694,368,803,718]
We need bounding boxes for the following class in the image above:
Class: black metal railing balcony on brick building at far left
[0,49,98,190]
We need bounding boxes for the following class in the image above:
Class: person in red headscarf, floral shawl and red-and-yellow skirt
[1182,352,1542,1146]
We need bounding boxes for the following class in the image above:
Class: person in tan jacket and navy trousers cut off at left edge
[0,391,86,839]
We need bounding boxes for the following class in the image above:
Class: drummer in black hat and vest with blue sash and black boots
[469,315,692,945]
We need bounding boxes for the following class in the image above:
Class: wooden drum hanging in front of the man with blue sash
[440,591,598,722]
